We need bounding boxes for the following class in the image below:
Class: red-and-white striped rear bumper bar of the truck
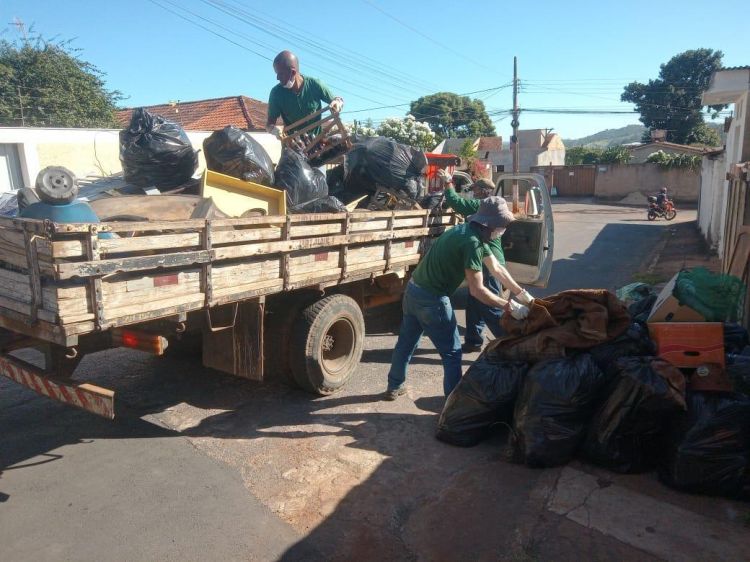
[0,355,115,419]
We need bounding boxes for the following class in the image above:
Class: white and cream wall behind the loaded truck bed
[0,127,281,187]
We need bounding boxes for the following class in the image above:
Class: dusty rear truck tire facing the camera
[289,295,365,395]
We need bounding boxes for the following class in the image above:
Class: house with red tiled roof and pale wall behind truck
[0,96,281,193]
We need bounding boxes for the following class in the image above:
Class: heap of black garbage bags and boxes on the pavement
[436,268,750,499]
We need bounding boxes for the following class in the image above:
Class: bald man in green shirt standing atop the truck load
[266,51,344,137]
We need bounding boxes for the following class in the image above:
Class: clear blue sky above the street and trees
[0,0,750,139]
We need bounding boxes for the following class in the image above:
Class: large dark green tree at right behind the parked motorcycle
[620,49,725,144]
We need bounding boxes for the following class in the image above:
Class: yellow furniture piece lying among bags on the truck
[201,170,286,217]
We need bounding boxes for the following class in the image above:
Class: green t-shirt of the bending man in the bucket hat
[412,223,490,296]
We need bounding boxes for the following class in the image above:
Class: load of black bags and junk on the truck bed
[5,108,434,220]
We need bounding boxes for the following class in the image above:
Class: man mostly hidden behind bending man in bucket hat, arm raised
[438,170,512,353]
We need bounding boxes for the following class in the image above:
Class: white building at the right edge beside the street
[698,66,750,258]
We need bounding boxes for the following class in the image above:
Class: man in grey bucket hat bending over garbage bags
[384,197,533,400]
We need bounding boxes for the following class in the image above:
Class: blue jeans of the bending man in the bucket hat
[388,281,461,396]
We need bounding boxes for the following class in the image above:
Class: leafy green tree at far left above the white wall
[0,37,122,127]
